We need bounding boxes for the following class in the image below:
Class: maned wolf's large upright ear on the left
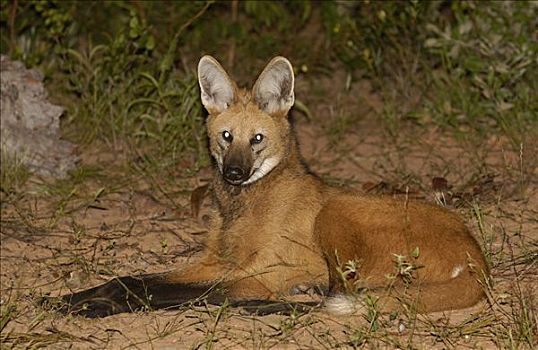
[198,56,235,114]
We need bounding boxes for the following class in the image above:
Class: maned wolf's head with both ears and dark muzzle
[198,56,295,185]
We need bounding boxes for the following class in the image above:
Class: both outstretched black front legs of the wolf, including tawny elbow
[47,259,318,317]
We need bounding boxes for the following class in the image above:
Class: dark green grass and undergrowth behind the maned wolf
[0,0,538,191]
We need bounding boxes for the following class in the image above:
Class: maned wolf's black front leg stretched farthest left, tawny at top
[45,256,233,317]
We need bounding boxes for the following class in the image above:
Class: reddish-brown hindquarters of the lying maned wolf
[316,195,487,312]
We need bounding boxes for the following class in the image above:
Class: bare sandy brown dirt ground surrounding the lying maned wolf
[0,76,538,349]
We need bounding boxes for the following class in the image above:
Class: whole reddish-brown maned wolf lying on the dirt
[53,56,488,317]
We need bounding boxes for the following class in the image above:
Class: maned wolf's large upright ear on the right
[252,56,295,115]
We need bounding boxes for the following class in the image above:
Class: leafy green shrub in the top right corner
[424,2,538,145]
